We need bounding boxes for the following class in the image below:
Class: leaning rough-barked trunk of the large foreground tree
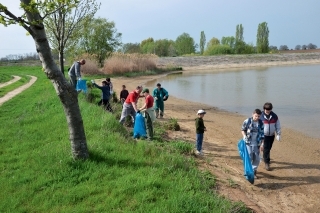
[21,0,89,159]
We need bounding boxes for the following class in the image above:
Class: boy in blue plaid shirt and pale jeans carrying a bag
[241,109,264,178]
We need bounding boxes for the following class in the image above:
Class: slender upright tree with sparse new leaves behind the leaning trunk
[39,0,100,73]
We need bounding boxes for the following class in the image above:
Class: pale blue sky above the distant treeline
[0,0,320,58]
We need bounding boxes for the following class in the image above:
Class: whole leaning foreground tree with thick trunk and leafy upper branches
[0,0,89,160]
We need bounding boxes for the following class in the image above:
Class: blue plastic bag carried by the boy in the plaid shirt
[238,139,254,184]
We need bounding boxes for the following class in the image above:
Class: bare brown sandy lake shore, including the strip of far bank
[107,53,320,212]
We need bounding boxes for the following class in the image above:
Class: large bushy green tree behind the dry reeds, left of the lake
[79,18,121,67]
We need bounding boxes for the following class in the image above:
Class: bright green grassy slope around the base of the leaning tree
[0,67,248,212]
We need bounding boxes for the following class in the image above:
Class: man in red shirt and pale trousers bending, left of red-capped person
[119,86,143,124]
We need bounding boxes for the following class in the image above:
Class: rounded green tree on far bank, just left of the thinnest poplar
[175,33,196,55]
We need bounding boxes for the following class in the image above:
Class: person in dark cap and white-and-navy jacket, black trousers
[260,102,281,171]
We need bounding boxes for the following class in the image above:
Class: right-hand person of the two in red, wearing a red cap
[139,88,156,140]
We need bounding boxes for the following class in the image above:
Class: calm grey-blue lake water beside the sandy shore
[148,65,320,138]
